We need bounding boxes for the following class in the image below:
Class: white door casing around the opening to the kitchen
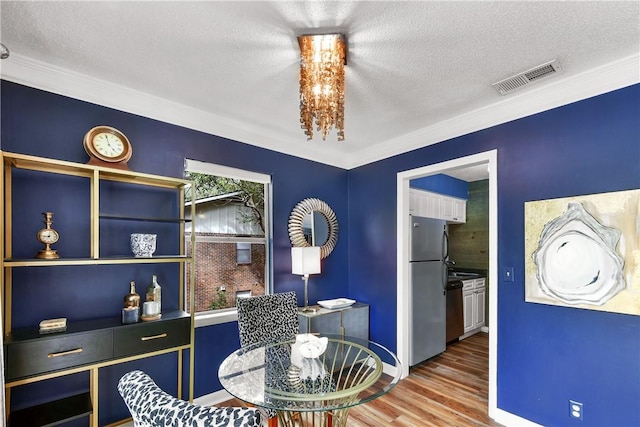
[396,150,498,419]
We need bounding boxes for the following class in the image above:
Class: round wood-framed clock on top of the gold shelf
[83,126,132,169]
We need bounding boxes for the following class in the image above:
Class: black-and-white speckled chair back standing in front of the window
[237,291,300,347]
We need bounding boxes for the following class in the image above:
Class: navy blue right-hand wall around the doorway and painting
[349,85,640,427]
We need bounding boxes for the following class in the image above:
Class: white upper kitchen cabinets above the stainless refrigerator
[409,188,467,223]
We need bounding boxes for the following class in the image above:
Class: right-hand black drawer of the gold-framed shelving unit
[113,317,191,357]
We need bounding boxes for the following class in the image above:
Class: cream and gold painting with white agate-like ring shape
[524,190,640,315]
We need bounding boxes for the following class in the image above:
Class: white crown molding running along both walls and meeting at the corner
[0,53,640,169]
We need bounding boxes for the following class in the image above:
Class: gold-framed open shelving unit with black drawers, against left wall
[0,152,195,426]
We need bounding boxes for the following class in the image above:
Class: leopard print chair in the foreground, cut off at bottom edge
[118,371,261,427]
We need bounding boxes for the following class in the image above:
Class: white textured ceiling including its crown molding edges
[0,0,640,172]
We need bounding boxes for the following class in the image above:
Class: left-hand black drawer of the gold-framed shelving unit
[6,330,113,381]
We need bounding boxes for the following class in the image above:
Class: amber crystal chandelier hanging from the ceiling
[298,34,346,141]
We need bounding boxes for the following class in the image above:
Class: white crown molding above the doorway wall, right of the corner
[346,54,640,169]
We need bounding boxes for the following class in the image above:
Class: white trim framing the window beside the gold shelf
[184,159,273,328]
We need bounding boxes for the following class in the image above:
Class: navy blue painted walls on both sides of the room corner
[1,81,640,427]
